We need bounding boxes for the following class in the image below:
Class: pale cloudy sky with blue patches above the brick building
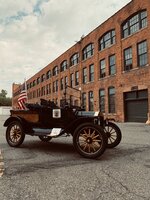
[0,0,130,97]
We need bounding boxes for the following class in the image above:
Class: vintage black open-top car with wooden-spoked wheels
[4,100,121,158]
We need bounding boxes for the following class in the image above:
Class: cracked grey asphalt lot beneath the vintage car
[0,115,150,200]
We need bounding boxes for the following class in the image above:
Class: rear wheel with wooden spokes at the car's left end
[6,121,25,147]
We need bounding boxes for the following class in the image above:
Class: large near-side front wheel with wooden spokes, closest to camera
[73,123,107,159]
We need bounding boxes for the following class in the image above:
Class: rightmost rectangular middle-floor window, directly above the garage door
[137,41,148,67]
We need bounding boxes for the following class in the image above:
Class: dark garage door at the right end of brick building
[124,90,148,122]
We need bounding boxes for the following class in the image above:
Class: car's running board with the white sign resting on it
[33,128,63,137]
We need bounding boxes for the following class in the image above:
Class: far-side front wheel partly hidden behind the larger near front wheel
[104,122,122,148]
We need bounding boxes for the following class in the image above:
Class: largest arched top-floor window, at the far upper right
[122,10,147,38]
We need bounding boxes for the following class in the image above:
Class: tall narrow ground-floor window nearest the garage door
[108,87,115,113]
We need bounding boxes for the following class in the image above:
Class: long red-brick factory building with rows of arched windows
[13,0,150,122]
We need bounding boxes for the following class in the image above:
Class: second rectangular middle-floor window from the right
[124,47,132,71]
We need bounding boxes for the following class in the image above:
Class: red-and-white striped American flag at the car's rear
[18,83,27,110]
